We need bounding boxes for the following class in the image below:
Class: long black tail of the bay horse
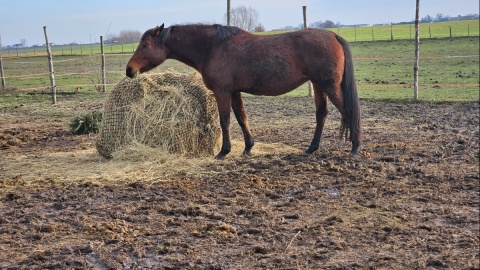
[336,35,362,143]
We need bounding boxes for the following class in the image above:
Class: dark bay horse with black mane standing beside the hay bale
[126,24,362,159]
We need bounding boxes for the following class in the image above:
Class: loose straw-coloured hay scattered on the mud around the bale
[3,140,300,185]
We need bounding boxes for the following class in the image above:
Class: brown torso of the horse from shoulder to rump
[204,29,343,95]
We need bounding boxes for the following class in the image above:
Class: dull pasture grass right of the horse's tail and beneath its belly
[280,37,480,101]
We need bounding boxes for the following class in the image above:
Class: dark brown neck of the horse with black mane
[165,26,217,71]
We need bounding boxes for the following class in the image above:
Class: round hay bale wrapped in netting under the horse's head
[96,72,221,158]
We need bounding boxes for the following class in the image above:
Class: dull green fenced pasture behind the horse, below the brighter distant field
[0,37,479,107]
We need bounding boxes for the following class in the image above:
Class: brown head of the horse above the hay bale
[126,24,167,78]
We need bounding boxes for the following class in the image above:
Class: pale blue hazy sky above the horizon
[0,0,479,46]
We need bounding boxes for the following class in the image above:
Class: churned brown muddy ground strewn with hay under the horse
[0,97,480,269]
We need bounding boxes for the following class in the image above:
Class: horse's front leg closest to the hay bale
[214,91,232,159]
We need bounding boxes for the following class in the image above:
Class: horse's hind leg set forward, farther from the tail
[305,84,328,154]
